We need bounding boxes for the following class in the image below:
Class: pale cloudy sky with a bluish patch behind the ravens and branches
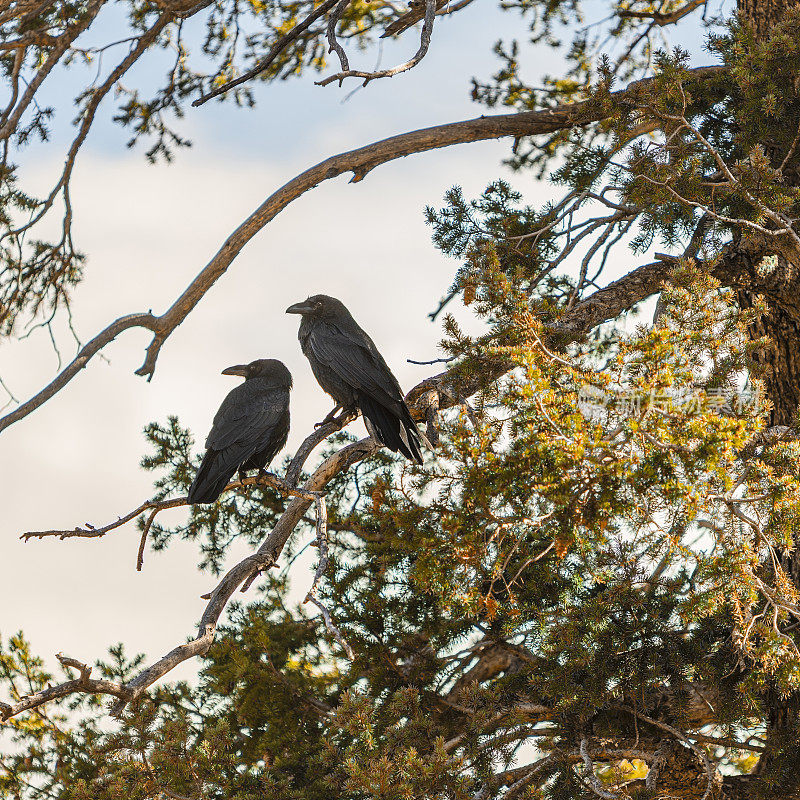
[0,2,712,688]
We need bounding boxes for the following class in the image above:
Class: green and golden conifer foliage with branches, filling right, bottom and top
[0,0,800,800]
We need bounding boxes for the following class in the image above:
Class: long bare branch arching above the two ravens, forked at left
[0,66,726,438]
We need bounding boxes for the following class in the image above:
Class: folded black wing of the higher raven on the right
[306,324,403,411]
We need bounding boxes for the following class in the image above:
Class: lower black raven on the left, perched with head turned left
[189,358,292,503]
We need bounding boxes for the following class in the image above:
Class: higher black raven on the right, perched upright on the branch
[286,294,427,464]
